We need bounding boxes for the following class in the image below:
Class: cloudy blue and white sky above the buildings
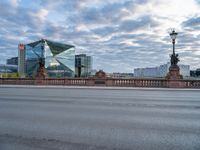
[0,0,200,73]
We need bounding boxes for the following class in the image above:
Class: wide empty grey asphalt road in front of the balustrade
[0,87,200,150]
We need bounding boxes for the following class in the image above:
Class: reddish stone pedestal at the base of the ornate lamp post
[166,65,183,80]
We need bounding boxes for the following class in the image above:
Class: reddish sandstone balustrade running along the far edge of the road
[0,78,200,88]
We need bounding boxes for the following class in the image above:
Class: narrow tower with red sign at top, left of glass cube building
[18,44,25,77]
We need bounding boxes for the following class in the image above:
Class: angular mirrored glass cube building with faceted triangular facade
[25,39,75,77]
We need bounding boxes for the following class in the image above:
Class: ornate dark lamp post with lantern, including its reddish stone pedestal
[166,29,183,80]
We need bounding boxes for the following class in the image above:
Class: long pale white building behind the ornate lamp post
[134,63,190,78]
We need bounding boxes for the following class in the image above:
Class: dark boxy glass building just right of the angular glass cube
[75,54,92,77]
